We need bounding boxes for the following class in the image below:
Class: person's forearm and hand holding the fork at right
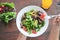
[48,17,60,40]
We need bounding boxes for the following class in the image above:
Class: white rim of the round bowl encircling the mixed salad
[16,5,49,37]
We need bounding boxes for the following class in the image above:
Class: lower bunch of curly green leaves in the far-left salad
[0,12,16,23]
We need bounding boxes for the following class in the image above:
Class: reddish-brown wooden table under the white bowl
[0,0,59,40]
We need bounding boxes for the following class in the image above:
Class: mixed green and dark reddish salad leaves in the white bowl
[21,9,45,34]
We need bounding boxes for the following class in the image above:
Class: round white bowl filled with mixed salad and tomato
[16,5,49,37]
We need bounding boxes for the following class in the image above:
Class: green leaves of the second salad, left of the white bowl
[0,2,16,23]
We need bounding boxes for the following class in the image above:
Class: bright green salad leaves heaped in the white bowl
[21,10,45,34]
